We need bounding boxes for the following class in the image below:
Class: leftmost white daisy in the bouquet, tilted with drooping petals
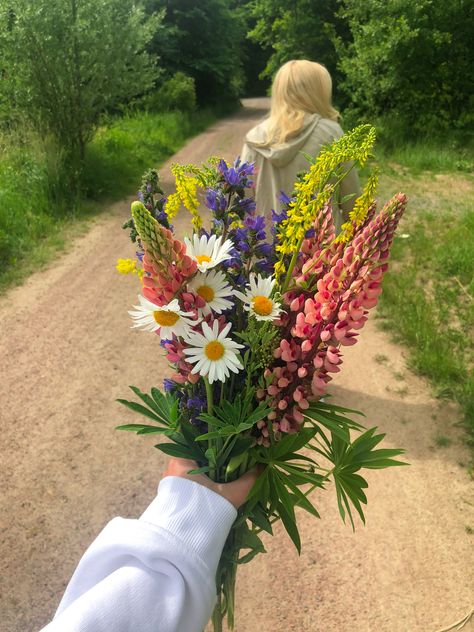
[128,296,198,340]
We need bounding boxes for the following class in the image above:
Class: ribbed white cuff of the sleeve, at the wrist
[140,476,237,574]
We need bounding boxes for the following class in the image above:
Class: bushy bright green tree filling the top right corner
[340,0,474,132]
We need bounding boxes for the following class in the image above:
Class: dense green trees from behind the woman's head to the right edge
[238,0,474,138]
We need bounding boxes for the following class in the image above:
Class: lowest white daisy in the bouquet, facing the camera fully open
[184,320,244,384]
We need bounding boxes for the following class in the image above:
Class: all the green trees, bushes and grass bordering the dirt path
[0,0,474,447]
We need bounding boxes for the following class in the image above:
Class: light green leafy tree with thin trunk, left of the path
[0,0,161,179]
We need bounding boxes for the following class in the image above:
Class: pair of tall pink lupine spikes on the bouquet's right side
[258,194,406,445]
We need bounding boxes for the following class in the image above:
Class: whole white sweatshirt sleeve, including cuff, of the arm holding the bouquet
[42,476,237,632]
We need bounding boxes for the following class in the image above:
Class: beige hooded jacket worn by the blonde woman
[241,114,360,232]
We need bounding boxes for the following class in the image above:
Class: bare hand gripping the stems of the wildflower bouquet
[163,457,258,509]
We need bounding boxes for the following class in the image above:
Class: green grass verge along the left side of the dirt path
[0,111,216,292]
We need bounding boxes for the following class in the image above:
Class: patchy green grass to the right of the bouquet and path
[379,164,474,446]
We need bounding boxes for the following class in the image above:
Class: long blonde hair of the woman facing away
[263,59,339,147]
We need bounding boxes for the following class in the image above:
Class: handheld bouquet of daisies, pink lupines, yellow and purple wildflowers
[119,125,406,630]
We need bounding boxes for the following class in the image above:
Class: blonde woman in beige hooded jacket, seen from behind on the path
[241,59,360,232]
